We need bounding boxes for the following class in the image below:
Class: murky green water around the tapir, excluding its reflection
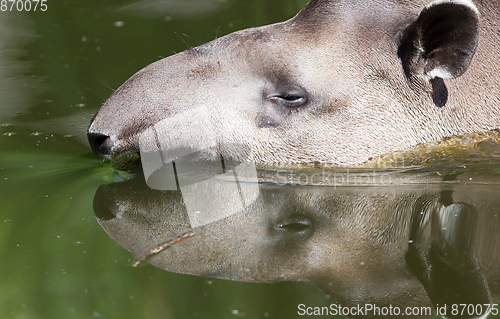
[0,0,500,319]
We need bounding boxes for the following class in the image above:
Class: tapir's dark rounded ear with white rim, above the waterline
[399,0,479,81]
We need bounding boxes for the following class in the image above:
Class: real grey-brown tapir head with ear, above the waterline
[88,0,479,164]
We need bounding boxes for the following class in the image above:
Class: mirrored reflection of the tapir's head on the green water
[94,178,500,317]
